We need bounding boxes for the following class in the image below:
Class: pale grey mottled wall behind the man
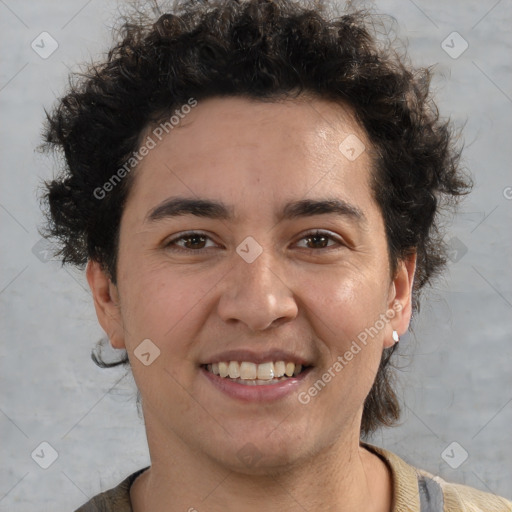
[0,0,512,512]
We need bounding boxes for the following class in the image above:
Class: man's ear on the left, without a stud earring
[86,260,125,348]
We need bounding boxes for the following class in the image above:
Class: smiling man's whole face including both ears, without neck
[87,98,414,471]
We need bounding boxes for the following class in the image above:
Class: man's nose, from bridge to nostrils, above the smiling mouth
[218,250,298,332]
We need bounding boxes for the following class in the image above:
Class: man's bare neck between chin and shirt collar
[130,412,392,512]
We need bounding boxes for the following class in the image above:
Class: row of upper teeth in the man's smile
[207,361,302,380]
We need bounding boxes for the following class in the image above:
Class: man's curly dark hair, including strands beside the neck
[42,0,472,437]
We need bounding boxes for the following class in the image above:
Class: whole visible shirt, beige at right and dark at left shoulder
[75,443,512,512]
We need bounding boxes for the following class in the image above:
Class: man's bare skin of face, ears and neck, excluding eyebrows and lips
[87,94,415,512]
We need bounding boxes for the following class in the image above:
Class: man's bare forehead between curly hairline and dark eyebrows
[122,98,373,222]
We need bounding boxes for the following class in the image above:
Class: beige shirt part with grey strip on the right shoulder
[361,443,512,512]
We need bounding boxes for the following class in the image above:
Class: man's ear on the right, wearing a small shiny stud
[384,252,417,348]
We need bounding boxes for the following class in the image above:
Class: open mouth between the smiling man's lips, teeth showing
[201,361,311,386]
